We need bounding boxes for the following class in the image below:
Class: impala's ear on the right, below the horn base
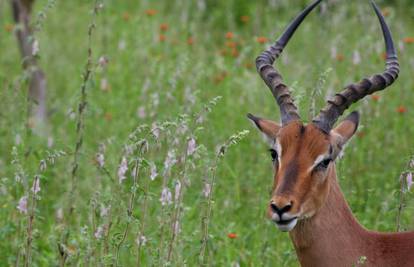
[330,111,359,153]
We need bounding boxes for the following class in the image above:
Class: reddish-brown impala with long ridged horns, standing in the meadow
[248,0,414,267]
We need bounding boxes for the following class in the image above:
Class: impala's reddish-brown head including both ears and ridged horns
[248,0,399,231]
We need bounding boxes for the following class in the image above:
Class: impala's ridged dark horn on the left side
[256,0,322,125]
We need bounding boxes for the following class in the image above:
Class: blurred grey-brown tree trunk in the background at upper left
[11,0,47,135]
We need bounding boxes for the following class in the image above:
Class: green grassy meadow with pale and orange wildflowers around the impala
[0,0,414,266]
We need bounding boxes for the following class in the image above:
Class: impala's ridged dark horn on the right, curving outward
[313,0,400,133]
